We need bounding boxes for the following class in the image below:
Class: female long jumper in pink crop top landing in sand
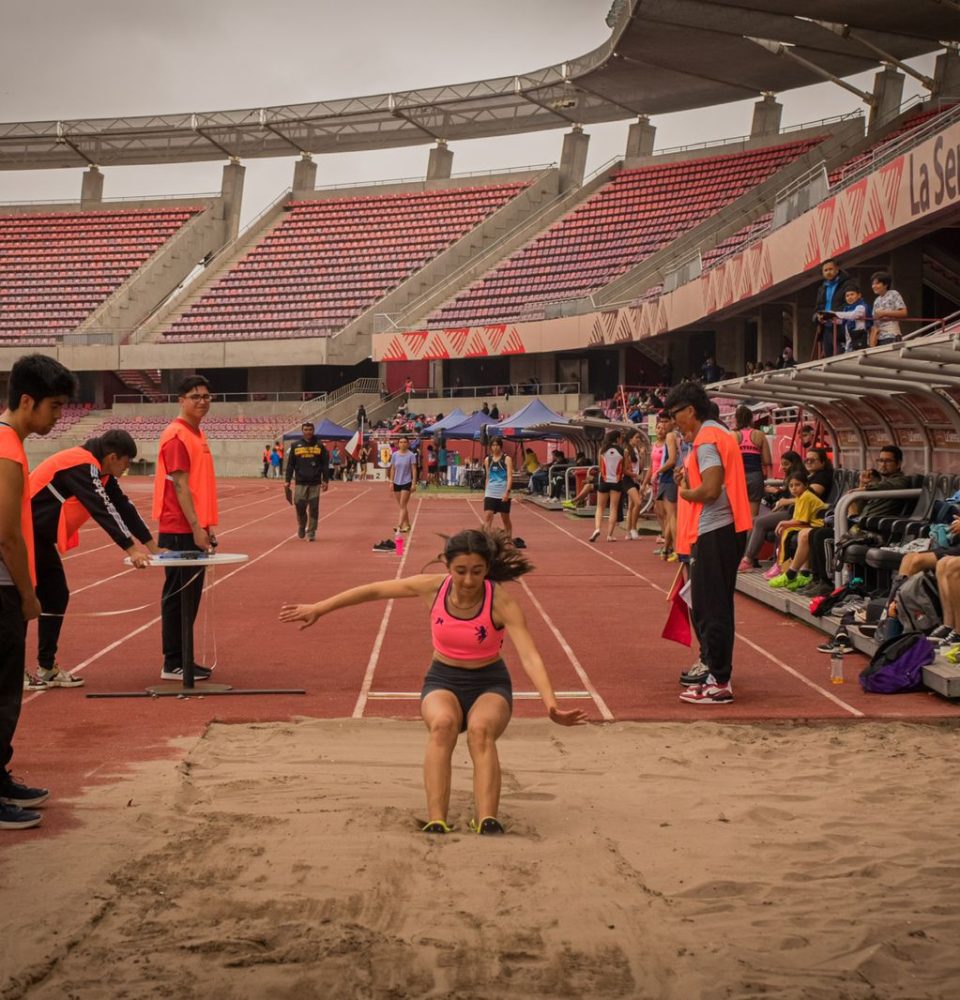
[280,529,586,834]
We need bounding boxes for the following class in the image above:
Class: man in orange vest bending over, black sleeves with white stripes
[24,430,159,691]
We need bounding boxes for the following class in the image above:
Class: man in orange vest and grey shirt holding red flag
[664,382,753,705]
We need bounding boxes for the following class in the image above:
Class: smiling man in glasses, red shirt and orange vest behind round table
[153,375,218,681]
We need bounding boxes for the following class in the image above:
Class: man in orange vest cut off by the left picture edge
[0,354,76,830]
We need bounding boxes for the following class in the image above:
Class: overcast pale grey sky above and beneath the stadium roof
[0,0,933,221]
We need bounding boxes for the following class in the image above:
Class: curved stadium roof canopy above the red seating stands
[0,0,960,170]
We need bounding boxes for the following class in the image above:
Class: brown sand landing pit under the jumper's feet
[0,719,960,1000]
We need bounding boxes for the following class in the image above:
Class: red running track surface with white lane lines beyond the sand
[11,478,960,839]
